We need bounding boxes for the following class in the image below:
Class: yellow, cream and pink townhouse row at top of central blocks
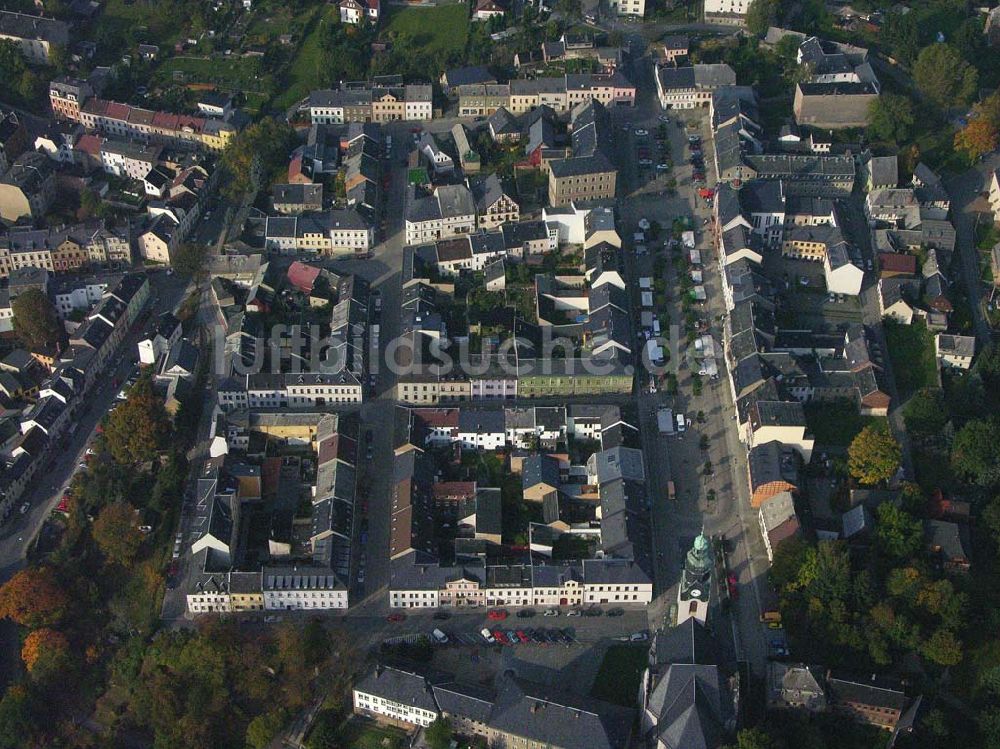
[456,71,635,117]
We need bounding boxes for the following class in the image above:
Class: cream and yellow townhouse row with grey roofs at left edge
[0,220,132,278]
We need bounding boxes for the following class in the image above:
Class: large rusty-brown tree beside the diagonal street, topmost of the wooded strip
[104,377,170,465]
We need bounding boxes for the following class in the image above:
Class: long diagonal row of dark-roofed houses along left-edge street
[0,274,150,518]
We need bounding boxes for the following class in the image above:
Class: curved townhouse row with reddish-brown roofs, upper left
[49,78,237,153]
